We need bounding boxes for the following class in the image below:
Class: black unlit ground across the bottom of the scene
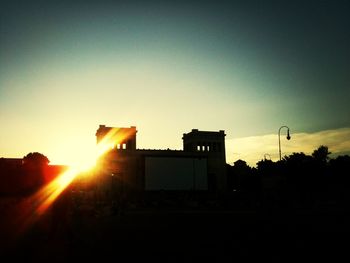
[1,206,350,262]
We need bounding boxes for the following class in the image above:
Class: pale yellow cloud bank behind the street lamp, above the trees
[226,128,350,166]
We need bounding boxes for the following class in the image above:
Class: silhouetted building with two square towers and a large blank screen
[96,125,226,200]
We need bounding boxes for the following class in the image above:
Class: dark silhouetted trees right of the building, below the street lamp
[227,145,350,209]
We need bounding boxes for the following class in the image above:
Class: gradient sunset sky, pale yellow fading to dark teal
[0,1,350,165]
